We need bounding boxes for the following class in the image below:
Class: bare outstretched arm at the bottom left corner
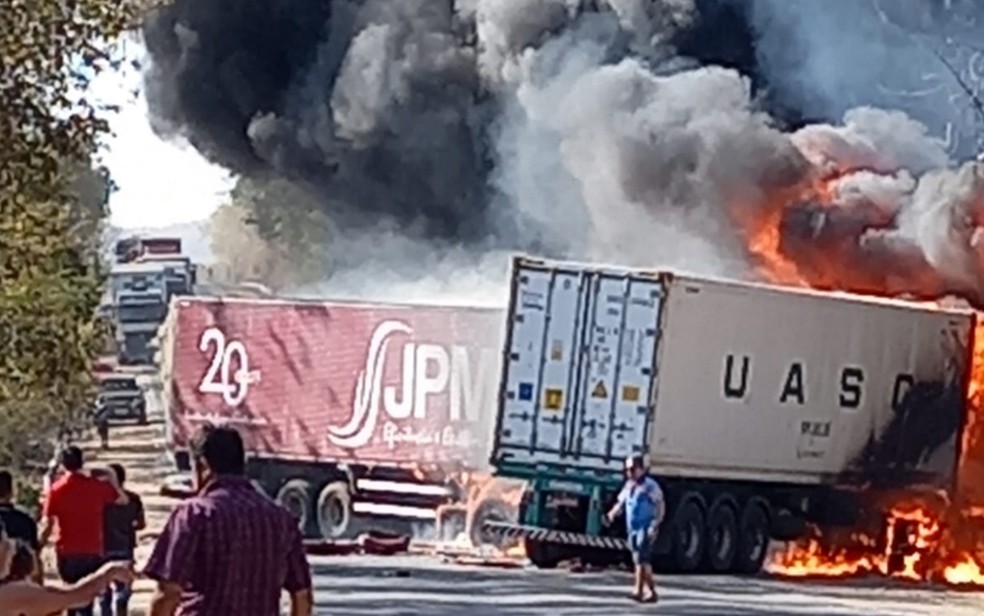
[0,563,133,614]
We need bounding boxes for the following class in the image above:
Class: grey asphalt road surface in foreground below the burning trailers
[311,556,984,616]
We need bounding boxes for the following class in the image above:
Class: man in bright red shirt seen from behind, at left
[40,446,129,616]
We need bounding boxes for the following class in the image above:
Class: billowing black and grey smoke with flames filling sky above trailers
[136,0,984,298]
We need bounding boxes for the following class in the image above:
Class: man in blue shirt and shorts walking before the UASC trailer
[608,456,666,603]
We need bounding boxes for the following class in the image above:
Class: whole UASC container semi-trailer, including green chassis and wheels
[485,258,975,573]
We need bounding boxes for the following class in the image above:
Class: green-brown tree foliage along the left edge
[0,0,134,464]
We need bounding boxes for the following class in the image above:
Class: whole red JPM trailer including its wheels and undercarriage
[159,297,508,539]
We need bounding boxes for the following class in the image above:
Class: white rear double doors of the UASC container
[493,260,663,471]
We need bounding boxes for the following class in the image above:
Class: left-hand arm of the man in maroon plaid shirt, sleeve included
[143,503,201,616]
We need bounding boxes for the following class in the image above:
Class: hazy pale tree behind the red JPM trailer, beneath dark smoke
[210,178,331,292]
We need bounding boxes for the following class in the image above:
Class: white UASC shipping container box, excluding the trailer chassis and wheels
[493,258,974,485]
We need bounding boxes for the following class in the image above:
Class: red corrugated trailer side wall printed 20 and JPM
[163,297,503,468]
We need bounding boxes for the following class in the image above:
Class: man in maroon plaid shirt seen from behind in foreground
[144,426,314,616]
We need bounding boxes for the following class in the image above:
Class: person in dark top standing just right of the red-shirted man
[99,464,147,616]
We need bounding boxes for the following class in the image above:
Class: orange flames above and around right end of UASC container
[734,164,984,587]
